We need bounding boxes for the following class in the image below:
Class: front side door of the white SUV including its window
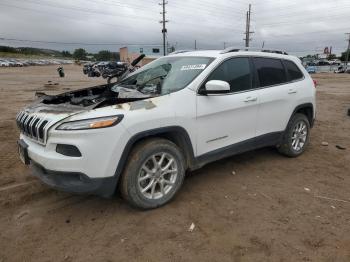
[196,57,258,155]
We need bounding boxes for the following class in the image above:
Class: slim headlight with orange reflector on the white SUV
[56,115,123,130]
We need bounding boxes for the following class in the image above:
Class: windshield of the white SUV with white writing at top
[112,57,214,95]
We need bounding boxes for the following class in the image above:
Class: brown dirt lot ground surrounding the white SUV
[0,65,350,262]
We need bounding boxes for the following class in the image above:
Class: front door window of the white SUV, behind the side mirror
[206,57,252,92]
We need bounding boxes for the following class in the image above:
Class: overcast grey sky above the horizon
[0,0,350,55]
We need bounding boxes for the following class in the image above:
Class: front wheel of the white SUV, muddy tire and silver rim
[120,138,185,209]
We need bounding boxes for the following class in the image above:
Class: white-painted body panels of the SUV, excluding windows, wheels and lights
[17,51,315,182]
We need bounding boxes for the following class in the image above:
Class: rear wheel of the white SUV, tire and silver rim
[278,113,310,157]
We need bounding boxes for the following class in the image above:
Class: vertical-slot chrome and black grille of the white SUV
[16,111,49,144]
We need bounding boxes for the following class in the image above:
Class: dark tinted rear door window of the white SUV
[254,57,287,87]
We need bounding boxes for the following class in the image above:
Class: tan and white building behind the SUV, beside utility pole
[119,46,162,66]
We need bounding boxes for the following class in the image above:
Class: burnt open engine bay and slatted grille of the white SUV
[16,84,152,144]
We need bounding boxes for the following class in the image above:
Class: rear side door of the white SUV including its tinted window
[253,57,303,137]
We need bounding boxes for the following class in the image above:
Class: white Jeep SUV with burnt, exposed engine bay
[16,49,315,209]
